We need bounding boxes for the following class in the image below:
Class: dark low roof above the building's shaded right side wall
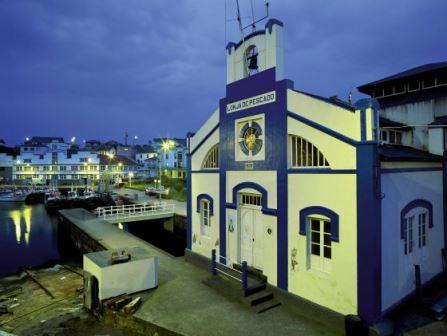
[379,144,442,162]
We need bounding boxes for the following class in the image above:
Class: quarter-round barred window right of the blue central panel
[289,135,329,167]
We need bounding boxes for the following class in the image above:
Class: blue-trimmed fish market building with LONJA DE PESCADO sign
[187,19,446,323]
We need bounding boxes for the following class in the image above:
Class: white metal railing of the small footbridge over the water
[97,202,175,219]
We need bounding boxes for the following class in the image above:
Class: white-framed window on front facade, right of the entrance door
[307,216,332,272]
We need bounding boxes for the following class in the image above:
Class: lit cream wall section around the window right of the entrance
[288,174,357,314]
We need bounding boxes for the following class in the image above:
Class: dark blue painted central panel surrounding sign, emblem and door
[219,68,293,289]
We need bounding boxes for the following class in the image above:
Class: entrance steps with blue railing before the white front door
[204,264,281,314]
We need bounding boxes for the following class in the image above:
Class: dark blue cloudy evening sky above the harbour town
[0,0,447,145]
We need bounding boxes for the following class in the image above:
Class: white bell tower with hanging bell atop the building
[226,19,284,84]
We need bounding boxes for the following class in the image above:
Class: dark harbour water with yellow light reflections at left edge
[0,202,59,275]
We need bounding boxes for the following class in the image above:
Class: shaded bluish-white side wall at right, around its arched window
[382,171,444,311]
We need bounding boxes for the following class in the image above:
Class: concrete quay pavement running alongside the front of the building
[60,209,344,336]
